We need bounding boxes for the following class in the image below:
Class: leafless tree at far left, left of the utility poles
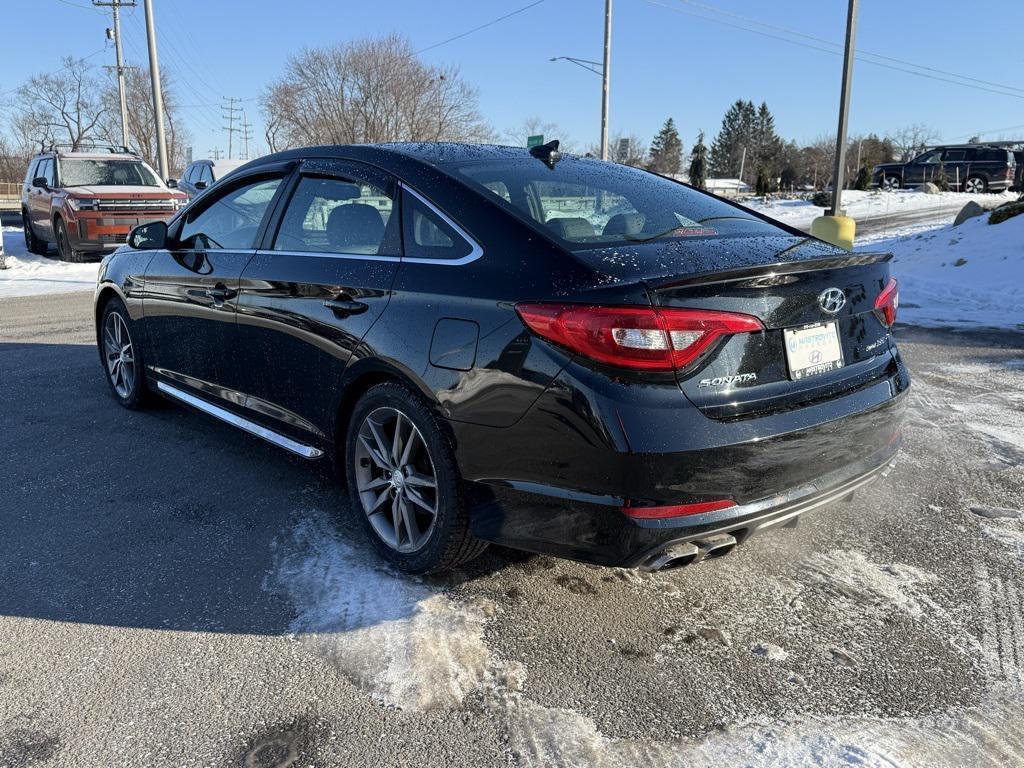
[13,56,106,150]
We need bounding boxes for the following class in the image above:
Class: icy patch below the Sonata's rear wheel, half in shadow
[266,511,494,710]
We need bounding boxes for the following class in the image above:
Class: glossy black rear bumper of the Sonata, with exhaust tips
[456,352,909,568]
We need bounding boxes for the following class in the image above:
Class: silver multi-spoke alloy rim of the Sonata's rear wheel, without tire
[353,407,438,553]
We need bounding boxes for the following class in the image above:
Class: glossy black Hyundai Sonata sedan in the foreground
[95,143,909,572]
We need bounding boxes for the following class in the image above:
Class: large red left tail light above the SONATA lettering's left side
[516,304,764,371]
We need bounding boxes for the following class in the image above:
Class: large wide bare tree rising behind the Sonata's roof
[262,35,492,148]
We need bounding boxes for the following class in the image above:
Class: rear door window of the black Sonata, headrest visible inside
[273,176,399,256]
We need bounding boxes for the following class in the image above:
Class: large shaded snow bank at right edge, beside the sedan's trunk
[857,210,1024,330]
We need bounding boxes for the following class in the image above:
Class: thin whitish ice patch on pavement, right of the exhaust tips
[801,550,937,617]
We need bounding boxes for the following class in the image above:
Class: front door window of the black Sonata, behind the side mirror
[178,176,281,250]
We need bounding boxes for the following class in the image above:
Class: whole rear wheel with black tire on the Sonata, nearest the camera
[344,383,486,573]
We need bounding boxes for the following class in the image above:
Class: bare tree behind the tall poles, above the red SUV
[98,68,190,174]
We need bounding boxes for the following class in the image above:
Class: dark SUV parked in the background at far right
[871,144,1017,193]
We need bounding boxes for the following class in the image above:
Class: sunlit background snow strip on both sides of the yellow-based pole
[743,189,1017,228]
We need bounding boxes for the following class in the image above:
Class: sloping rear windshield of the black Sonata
[456,158,779,248]
